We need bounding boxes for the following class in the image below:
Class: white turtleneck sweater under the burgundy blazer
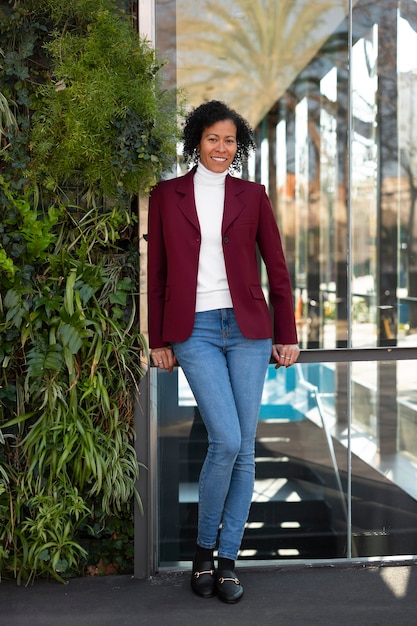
[194,163,233,311]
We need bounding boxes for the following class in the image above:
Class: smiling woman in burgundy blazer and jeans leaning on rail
[148,101,299,603]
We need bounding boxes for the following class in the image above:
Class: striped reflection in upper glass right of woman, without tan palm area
[256,0,417,348]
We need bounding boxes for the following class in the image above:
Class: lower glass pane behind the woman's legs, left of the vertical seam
[153,364,347,565]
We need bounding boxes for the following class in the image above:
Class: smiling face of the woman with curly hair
[197,120,237,174]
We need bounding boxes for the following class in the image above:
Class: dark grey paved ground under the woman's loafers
[0,564,417,626]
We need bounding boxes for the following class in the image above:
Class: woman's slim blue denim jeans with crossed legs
[172,309,272,560]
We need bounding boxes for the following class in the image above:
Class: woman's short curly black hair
[183,100,256,170]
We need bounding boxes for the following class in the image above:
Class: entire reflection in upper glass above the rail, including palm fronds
[156,0,417,348]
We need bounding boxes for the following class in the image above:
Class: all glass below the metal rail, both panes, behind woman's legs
[152,361,417,565]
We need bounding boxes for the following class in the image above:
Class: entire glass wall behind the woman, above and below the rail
[152,0,417,564]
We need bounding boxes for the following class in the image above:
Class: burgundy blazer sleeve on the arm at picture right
[257,186,298,344]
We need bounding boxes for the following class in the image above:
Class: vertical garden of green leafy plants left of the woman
[0,0,179,582]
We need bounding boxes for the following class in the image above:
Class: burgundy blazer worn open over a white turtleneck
[148,168,297,348]
